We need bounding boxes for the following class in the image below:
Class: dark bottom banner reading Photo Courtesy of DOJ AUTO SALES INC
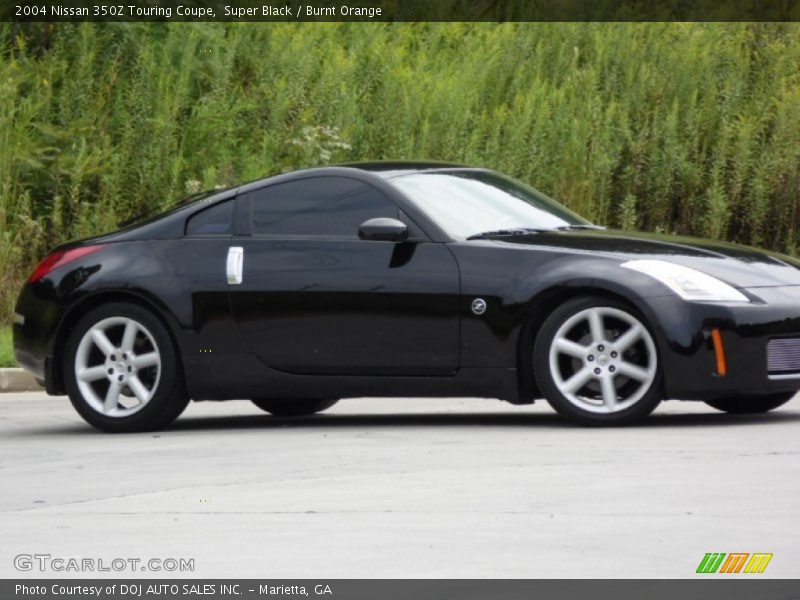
[0,578,800,600]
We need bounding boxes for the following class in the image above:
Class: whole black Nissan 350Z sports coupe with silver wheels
[14,163,800,431]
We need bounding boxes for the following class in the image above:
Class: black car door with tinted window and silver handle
[229,176,459,376]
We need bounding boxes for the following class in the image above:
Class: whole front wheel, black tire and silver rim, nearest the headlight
[533,297,661,425]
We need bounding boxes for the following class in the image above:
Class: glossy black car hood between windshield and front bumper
[494,229,800,288]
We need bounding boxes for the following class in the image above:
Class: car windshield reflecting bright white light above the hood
[388,171,590,239]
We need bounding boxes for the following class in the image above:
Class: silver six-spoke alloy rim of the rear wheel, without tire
[75,317,161,417]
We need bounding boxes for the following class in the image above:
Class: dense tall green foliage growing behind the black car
[0,23,800,320]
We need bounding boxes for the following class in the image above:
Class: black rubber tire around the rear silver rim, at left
[62,302,189,433]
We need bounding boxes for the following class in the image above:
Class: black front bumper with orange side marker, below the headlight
[650,286,800,400]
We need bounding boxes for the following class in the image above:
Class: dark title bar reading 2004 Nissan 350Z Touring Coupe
[0,0,800,23]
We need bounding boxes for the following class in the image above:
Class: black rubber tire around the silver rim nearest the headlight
[532,296,663,426]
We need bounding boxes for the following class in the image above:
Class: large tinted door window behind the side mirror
[242,177,398,238]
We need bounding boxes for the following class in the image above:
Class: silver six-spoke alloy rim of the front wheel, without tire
[549,306,658,413]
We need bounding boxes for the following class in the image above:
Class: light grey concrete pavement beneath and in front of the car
[0,393,800,578]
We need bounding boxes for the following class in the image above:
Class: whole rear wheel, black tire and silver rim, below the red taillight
[64,302,188,432]
